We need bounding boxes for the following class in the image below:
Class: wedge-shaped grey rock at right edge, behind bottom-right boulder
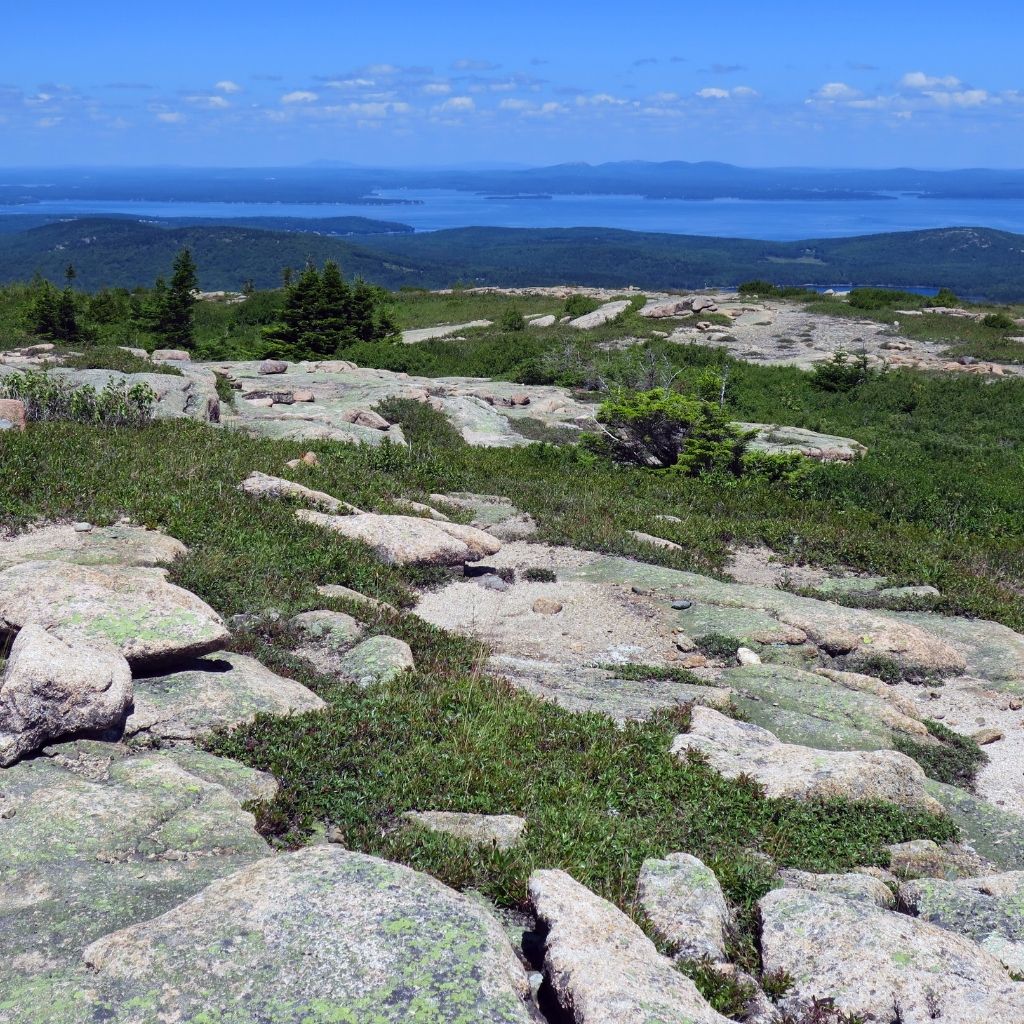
[899,871,1024,975]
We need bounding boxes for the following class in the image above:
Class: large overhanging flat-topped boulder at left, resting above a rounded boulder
[0,561,228,668]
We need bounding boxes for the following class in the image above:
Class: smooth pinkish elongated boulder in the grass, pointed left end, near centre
[295,509,502,565]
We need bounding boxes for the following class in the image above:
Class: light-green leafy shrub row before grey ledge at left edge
[0,370,157,427]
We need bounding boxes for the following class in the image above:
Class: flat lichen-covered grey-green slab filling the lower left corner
[0,741,268,1007]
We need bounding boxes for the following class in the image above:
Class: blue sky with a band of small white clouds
[0,0,1024,167]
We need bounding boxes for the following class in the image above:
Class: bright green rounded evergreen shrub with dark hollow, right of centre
[584,388,748,476]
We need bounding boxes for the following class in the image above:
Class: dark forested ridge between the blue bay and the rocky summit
[0,217,1024,301]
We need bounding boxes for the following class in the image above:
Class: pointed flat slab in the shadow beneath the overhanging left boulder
[124,652,324,740]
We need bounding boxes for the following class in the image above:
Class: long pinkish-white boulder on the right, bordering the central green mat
[672,707,941,813]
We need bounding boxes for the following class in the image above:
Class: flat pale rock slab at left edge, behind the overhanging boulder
[0,523,187,569]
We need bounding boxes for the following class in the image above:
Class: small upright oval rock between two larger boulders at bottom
[637,853,732,962]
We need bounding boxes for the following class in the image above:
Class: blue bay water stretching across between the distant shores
[0,189,1024,242]
